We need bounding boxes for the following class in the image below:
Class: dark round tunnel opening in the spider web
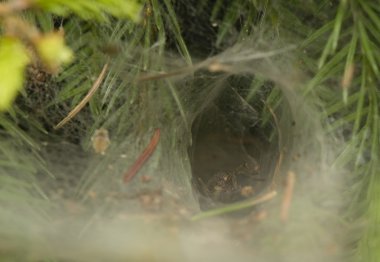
[189,79,278,210]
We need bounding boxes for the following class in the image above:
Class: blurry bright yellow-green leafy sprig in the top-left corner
[0,0,141,111]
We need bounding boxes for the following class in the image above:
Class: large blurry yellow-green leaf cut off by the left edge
[0,37,30,111]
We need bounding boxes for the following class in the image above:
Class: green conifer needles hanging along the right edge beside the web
[296,0,380,261]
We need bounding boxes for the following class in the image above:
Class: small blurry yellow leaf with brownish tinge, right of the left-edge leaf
[34,32,73,73]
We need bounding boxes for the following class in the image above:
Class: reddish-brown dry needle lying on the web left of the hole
[123,128,160,184]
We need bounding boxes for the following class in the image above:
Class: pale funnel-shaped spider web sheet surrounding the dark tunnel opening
[2,38,344,261]
